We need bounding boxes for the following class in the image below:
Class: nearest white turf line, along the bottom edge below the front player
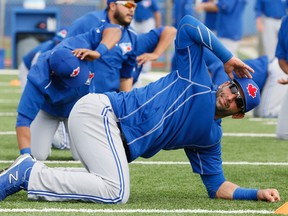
[0,208,274,214]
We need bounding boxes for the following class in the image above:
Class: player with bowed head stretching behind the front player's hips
[16,24,121,160]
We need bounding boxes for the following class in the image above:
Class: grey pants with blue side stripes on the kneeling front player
[28,94,130,203]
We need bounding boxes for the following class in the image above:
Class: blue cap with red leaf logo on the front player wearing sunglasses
[233,78,260,112]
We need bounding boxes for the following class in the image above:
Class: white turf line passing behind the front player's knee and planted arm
[0,160,288,166]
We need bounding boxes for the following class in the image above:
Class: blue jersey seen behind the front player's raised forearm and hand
[204,49,269,91]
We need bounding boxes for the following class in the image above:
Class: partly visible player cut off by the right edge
[276,16,288,140]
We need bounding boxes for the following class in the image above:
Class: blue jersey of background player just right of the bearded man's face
[134,0,159,22]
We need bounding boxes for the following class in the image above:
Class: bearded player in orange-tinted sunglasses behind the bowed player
[67,0,141,93]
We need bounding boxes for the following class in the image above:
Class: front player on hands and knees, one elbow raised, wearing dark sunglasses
[0,16,280,203]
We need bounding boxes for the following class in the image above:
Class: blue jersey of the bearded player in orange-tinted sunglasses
[68,10,137,93]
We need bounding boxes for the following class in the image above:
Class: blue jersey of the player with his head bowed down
[16,26,112,127]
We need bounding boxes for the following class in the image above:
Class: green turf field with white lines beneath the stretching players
[0,73,288,216]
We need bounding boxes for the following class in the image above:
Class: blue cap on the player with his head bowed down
[49,48,90,88]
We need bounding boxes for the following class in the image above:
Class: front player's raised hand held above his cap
[224,56,254,79]
